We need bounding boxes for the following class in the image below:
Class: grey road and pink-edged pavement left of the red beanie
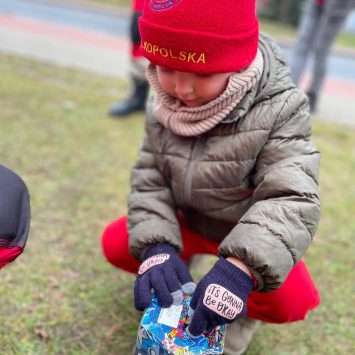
[0,0,129,78]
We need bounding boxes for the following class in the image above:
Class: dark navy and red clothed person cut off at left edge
[0,165,30,269]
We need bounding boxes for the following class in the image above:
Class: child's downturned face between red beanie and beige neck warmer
[157,66,232,107]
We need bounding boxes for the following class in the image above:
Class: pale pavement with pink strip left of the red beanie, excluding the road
[0,13,129,78]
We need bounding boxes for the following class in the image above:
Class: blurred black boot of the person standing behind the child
[109,78,149,117]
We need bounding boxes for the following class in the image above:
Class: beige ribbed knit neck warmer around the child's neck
[147,50,264,136]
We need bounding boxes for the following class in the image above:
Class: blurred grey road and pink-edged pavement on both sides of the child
[0,0,355,126]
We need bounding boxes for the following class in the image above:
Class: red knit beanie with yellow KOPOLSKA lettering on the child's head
[139,0,259,74]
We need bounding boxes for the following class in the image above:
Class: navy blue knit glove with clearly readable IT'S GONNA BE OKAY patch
[187,258,253,337]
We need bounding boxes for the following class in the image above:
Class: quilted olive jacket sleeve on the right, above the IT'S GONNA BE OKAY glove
[219,89,320,291]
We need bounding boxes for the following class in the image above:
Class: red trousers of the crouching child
[102,217,320,323]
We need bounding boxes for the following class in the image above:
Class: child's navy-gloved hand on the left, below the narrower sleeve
[134,244,196,311]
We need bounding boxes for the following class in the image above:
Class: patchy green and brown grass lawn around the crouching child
[0,54,355,355]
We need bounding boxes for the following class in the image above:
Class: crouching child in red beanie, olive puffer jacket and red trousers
[102,0,320,354]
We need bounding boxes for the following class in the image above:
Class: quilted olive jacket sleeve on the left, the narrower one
[128,112,182,259]
